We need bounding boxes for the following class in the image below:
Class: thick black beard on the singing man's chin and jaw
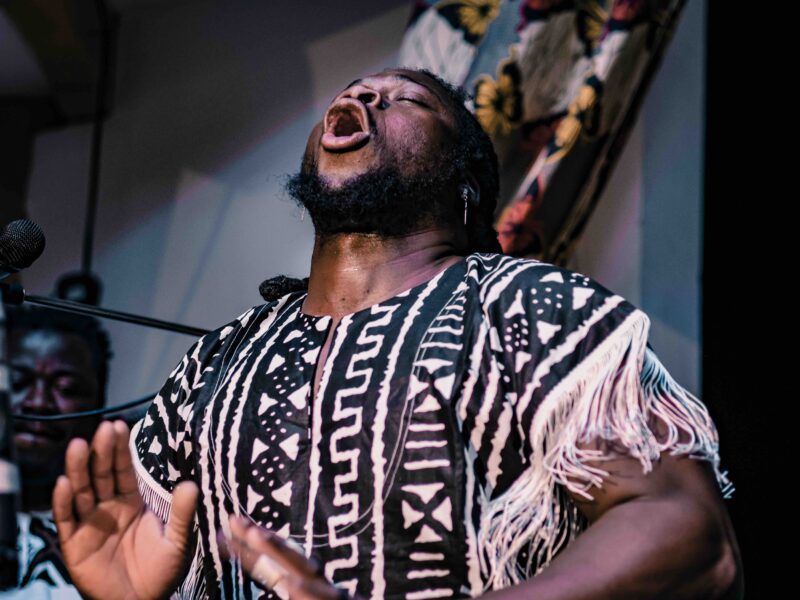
[286,152,458,237]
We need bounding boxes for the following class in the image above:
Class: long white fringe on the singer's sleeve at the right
[478,309,733,591]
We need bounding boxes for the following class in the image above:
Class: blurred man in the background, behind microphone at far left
[8,307,111,598]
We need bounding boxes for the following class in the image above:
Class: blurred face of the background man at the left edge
[10,330,102,474]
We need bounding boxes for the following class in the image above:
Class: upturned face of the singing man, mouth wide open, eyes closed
[303,69,456,189]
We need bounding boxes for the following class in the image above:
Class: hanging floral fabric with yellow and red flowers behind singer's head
[399,0,684,265]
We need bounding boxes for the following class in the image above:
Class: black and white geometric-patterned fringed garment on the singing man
[131,253,732,600]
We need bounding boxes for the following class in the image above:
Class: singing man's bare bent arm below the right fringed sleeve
[482,444,744,600]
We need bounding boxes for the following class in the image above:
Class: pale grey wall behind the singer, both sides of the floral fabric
[25,0,704,403]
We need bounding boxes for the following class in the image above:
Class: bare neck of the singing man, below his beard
[303,229,461,318]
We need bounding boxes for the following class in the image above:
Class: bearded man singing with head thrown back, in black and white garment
[53,69,743,600]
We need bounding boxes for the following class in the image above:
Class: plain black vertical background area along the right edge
[702,1,780,599]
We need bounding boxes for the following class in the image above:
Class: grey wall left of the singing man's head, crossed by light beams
[25,0,410,403]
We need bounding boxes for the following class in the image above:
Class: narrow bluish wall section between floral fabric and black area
[569,0,706,395]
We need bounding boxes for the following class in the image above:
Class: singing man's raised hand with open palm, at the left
[53,421,198,600]
